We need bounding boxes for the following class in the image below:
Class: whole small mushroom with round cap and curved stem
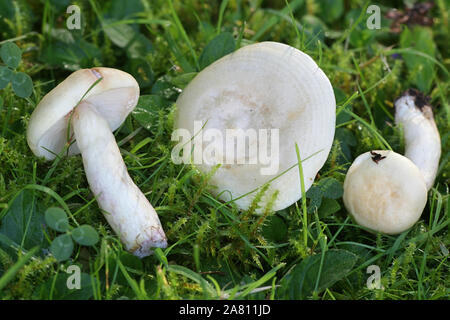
[343,90,441,234]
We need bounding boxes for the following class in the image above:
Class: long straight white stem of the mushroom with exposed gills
[72,102,167,257]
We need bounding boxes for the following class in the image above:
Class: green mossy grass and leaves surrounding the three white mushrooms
[0,0,450,300]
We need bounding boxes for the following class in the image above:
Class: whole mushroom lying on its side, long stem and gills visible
[27,68,167,257]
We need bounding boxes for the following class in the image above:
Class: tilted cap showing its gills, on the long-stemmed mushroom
[27,67,139,160]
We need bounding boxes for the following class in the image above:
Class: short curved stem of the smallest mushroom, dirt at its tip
[395,89,441,190]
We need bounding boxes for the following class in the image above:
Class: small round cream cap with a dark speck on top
[343,150,427,234]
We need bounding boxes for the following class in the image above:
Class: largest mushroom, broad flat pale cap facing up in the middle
[172,42,336,212]
